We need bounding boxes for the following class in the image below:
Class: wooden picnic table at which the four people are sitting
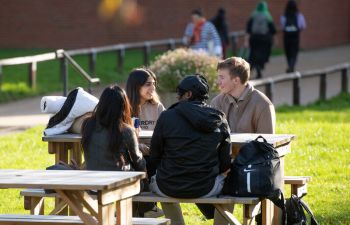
[42,130,295,224]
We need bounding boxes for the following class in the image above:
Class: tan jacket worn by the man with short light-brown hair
[211,84,276,134]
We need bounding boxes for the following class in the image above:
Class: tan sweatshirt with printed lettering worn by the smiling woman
[139,102,165,130]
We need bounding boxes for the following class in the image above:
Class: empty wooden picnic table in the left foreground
[0,170,146,225]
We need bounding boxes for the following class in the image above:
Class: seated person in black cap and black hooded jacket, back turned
[147,74,231,224]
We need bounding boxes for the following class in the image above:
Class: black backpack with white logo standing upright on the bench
[223,136,282,199]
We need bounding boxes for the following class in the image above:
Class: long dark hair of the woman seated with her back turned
[82,85,131,155]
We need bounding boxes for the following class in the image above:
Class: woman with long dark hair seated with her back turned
[82,85,146,171]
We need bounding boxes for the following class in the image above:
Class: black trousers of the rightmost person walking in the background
[283,34,299,72]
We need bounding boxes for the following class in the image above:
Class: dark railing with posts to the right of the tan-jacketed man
[250,63,350,105]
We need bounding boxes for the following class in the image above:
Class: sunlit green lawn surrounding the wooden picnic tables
[0,94,350,225]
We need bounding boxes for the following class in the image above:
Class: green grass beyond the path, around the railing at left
[0,49,161,103]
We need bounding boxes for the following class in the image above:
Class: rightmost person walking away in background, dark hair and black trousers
[281,0,306,73]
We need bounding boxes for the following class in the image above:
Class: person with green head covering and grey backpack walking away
[245,1,276,78]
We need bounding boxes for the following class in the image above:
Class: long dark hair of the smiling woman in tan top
[126,68,159,117]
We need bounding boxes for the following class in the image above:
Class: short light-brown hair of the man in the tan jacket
[216,57,250,84]
